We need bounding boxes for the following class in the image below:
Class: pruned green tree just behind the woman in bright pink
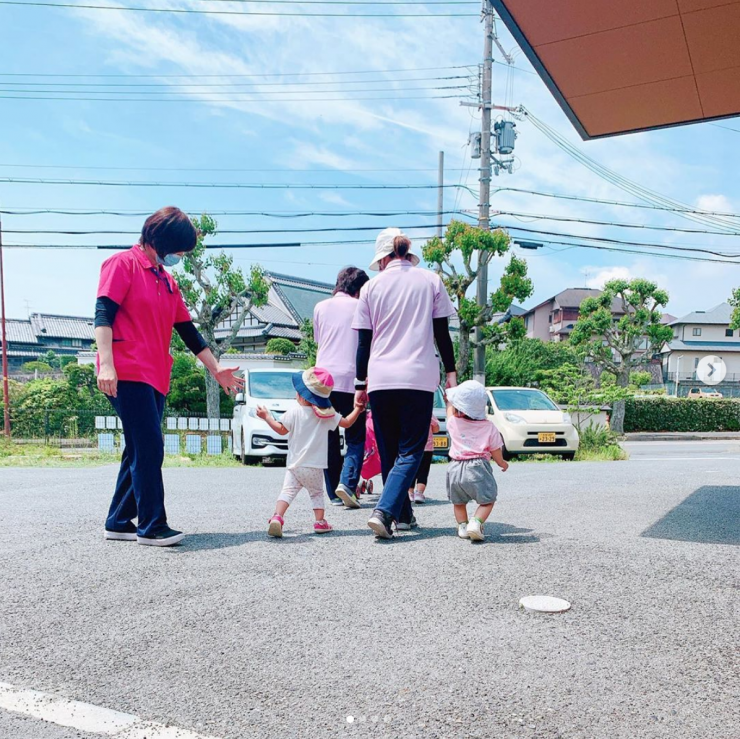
[175,214,270,418]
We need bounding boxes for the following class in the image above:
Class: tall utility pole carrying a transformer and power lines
[473,0,494,385]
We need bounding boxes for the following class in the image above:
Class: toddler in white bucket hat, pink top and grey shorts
[447,380,509,541]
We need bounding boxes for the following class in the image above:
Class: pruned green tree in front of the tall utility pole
[423,220,534,379]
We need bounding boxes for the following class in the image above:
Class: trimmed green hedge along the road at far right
[624,397,740,431]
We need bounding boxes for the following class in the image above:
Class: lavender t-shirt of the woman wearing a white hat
[352,259,455,392]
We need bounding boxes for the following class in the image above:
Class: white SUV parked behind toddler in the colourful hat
[231,369,297,464]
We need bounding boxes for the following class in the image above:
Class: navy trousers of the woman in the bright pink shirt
[105,381,167,536]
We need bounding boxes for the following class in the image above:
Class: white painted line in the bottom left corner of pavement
[0,683,217,739]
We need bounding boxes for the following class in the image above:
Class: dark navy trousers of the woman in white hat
[370,390,434,523]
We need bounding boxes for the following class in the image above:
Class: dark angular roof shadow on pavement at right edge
[641,486,740,546]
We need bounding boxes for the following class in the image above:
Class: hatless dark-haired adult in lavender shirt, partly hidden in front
[313,267,370,508]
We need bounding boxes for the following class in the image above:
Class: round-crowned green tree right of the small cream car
[571,278,673,433]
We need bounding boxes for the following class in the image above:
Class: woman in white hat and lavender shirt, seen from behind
[352,228,457,539]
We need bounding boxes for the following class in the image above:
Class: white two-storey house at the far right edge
[662,303,740,382]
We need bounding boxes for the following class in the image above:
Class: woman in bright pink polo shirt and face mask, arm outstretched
[95,207,243,546]
